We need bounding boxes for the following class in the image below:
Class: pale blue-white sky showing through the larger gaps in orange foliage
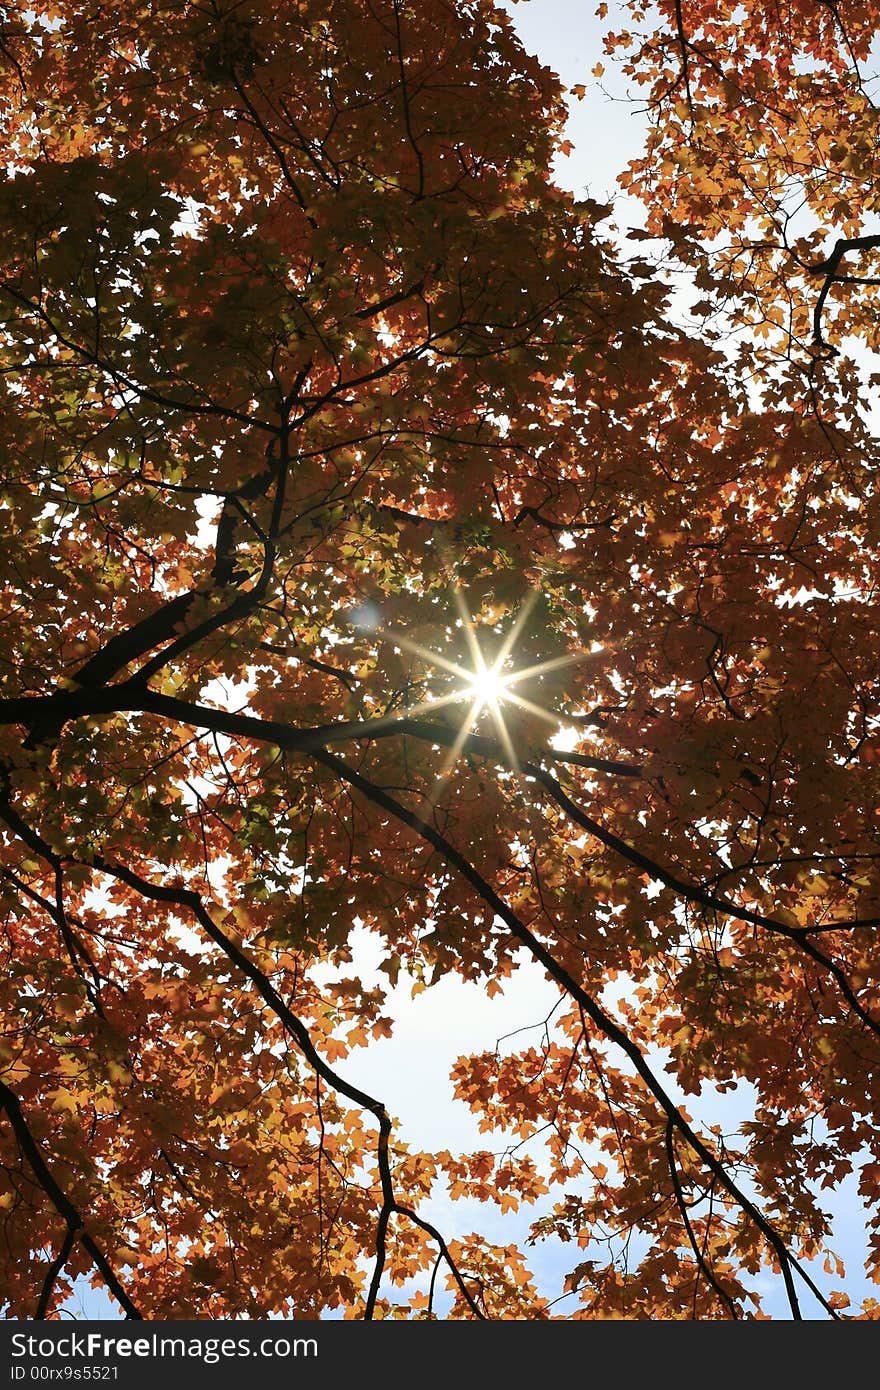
[58,0,876,1318]
